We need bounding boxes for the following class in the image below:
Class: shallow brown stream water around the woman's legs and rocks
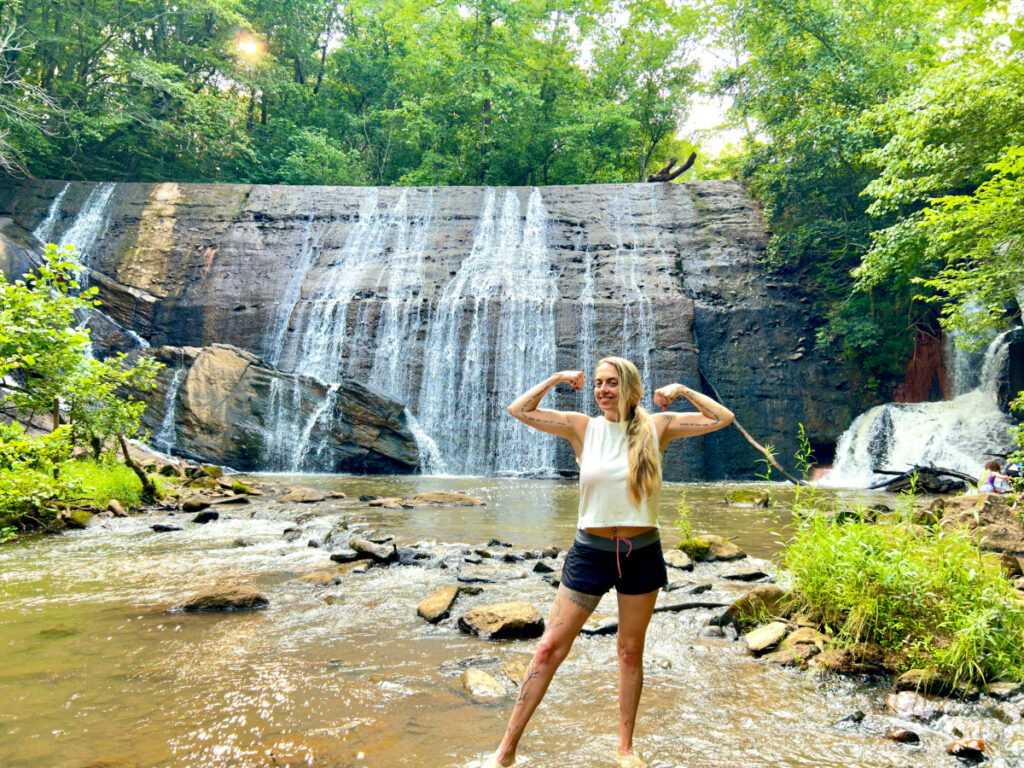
[0,476,1024,768]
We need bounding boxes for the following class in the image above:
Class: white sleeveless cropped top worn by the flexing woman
[577,416,662,528]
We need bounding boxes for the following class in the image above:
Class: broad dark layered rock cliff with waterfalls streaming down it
[0,181,871,479]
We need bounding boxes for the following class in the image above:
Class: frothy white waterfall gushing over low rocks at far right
[822,331,1013,487]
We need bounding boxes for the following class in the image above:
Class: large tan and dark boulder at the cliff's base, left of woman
[144,344,419,473]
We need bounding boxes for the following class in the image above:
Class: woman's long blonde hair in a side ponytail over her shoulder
[594,357,662,507]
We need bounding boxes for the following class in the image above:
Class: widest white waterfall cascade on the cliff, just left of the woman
[419,189,557,474]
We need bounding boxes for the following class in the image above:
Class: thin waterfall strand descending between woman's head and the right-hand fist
[612,185,656,410]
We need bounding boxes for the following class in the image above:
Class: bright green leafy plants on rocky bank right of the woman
[784,496,1024,682]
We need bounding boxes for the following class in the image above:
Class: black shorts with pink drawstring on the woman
[561,539,669,595]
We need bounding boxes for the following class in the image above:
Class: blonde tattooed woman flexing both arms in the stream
[483,357,732,768]
